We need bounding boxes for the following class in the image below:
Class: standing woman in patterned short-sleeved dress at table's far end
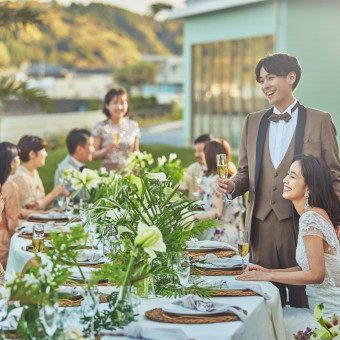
[92,88,140,171]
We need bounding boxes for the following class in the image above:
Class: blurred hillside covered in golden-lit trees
[0,1,182,69]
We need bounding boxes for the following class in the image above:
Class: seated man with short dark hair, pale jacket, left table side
[54,129,95,201]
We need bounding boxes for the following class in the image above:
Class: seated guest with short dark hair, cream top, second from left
[13,136,68,210]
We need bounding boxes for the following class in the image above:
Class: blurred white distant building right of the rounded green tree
[141,55,184,104]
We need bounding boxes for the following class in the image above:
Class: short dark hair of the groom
[255,53,302,90]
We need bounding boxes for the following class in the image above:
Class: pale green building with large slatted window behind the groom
[170,0,340,148]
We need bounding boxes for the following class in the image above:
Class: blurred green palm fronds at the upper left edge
[0,1,53,111]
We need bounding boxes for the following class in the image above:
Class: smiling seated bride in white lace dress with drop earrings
[237,155,340,339]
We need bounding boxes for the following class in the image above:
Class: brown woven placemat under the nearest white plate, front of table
[145,308,240,325]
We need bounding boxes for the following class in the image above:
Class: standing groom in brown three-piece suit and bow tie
[219,53,340,307]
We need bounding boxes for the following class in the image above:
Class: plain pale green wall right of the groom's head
[281,0,340,134]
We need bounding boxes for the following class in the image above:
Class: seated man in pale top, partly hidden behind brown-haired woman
[180,133,213,200]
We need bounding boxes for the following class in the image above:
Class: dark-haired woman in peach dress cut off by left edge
[0,142,21,270]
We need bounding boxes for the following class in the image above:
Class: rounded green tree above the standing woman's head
[114,61,157,89]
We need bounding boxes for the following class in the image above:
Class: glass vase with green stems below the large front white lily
[115,286,136,327]
